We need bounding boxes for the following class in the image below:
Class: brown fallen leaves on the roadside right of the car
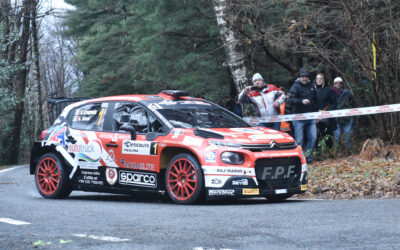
[301,145,400,199]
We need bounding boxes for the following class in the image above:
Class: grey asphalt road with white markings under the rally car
[0,166,400,250]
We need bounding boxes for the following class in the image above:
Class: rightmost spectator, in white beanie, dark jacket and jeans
[332,77,355,148]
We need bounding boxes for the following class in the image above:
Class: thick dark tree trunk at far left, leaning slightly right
[10,0,32,164]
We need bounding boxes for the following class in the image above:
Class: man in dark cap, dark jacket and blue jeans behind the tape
[289,68,318,163]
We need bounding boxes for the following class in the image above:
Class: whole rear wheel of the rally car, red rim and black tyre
[35,153,71,199]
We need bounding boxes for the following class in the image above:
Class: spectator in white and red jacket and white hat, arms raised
[239,73,285,130]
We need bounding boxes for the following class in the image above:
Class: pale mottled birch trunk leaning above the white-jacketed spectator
[213,0,250,93]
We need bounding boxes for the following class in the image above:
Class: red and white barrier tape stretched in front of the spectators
[243,103,400,125]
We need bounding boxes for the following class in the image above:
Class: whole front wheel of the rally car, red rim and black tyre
[165,153,204,204]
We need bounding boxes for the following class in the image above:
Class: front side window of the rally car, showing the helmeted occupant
[113,103,162,134]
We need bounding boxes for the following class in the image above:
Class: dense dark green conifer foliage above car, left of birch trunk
[65,0,230,100]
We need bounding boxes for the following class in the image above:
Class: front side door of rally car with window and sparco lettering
[109,102,162,188]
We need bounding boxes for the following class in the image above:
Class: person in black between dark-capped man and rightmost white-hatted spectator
[316,73,337,148]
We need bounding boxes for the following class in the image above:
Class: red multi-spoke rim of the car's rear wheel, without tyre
[36,157,60,195]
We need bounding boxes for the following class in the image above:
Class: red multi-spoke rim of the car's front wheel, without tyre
[167,158,198,201]
